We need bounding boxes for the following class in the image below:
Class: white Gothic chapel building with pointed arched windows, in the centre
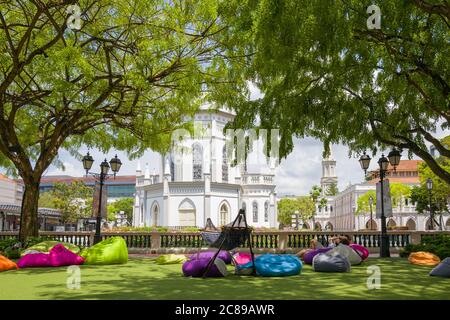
[133,107,277,227]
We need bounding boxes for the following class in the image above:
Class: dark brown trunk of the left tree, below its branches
[19,181,39,242]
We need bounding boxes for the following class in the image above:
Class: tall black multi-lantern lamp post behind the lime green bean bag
[82,152,122,244]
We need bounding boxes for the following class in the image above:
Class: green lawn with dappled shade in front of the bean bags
[0,258,450,299]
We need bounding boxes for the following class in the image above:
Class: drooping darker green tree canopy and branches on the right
[229,0,450,183]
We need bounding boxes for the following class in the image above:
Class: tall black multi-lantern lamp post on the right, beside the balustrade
[359,148,401,258]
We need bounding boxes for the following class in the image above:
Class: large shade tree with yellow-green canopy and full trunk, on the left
[0,0,247,240]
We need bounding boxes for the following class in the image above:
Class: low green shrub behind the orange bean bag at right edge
[400,234,450,259]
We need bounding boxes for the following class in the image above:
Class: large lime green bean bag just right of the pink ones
[80,237,128,264]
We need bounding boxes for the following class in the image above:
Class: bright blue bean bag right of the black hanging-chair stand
[236,254,302,277]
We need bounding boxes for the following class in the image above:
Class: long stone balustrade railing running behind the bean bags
[0,231,450,250]
